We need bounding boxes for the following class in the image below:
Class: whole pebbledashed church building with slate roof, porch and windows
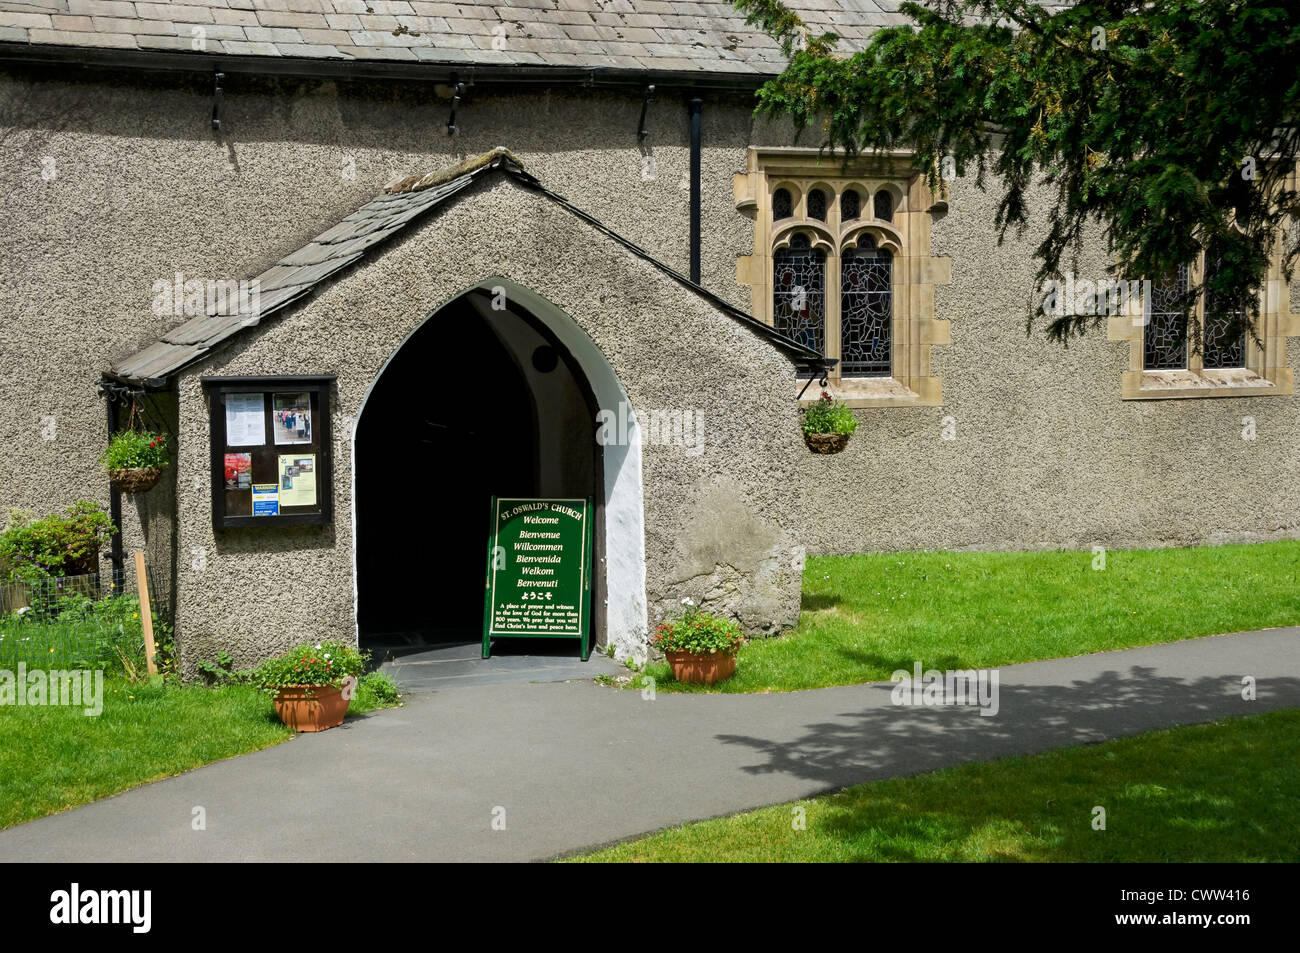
[0,0,1300,671]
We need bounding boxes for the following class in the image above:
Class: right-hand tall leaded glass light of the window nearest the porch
[840,237,893,377]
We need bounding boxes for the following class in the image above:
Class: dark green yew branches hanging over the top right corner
[735,0,1300,343]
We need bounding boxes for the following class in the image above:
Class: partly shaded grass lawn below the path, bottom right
[575,711,1300,862]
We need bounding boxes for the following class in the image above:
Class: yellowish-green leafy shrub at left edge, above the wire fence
[0,499,117,581]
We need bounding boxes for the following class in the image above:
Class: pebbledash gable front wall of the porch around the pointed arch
[167,177,806,660]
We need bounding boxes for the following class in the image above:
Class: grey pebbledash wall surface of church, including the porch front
[0,69,1300,654]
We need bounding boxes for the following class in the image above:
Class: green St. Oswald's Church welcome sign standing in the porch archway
[484,497,593,662]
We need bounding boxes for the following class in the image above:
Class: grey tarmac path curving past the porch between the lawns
[0,628,1300,861]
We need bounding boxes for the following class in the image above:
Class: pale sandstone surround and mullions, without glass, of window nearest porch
[733,147,952,407]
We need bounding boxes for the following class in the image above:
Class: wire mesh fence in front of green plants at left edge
[0,566,172,677]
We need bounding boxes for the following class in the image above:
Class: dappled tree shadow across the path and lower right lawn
[718,663,1300,861]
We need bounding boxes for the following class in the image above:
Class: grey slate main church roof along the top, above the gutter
[0,0,910,75]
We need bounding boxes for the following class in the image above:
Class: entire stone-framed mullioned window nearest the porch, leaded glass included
[735,148,949,407]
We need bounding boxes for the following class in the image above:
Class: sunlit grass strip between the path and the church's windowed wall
[633,541,1300,692]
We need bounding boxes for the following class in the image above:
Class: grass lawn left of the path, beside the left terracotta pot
[0,677,400,828]
